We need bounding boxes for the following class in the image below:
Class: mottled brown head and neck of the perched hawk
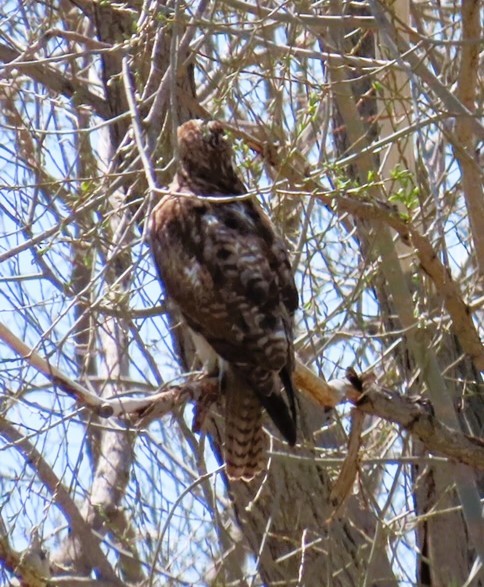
[178,119,245,195]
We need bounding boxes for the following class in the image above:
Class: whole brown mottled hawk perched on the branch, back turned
[150,120,298,480]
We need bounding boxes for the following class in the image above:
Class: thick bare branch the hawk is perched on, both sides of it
[0,324,484,470]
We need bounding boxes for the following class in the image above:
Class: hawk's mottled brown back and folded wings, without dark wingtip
[151,196,297,372]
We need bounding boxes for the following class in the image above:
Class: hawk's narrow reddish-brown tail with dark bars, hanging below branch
[225,373,268,481]
